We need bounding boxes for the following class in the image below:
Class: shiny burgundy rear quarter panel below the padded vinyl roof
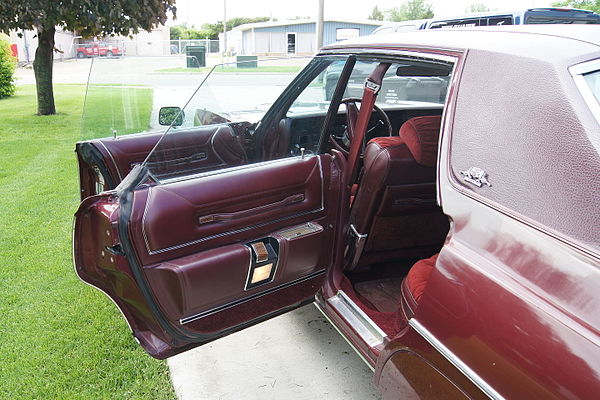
[415,43,600,399]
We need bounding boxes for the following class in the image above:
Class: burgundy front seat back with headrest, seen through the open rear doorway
[347,116,449,269]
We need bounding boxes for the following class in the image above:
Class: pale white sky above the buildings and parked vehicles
[170,0,552,27]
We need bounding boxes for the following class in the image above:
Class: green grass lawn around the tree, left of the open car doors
[0,85,175,399]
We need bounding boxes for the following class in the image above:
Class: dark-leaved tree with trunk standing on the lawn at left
[0,0,176,115]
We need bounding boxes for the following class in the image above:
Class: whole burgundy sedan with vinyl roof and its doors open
[74,26,600,399]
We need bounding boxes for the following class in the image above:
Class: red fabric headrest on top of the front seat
[400,115,442,167]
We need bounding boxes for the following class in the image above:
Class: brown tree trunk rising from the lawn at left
[33,27,56,115]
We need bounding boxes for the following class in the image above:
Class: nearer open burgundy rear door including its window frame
[74,54,346,358]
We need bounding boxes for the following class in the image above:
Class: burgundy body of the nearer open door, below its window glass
[74,154,341,358]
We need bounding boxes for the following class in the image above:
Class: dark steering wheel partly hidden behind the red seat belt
[329,97,393,156]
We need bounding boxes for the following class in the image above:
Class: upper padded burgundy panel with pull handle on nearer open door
[131,157,326,264]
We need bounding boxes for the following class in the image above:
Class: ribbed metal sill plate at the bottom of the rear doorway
[327,290,387,347]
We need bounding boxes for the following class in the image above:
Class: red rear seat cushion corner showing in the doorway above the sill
[400,254,438,320]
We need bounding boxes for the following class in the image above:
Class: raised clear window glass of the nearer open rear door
[139,57,347,182]
